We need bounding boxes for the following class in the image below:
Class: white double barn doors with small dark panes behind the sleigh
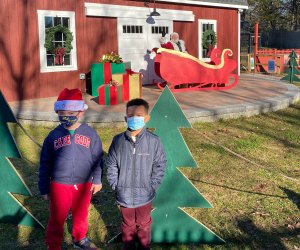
[118,17,173,85]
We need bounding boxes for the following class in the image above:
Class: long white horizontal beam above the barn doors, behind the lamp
[84,3,195,22]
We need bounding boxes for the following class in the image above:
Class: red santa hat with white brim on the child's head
[54,88,88,112]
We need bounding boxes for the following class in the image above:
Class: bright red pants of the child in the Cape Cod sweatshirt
[46,181,92,250]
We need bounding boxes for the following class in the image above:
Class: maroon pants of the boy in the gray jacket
[121,202,152,250]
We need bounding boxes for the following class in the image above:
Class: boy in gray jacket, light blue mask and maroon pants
[106,98,166,249]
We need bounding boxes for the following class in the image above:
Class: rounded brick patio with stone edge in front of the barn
[9,74,300,125]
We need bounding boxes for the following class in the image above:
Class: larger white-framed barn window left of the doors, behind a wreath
[38,10,77,72]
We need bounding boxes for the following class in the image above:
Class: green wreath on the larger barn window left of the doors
[44,25,73,54]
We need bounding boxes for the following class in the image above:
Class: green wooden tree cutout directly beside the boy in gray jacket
[147,87,224,243]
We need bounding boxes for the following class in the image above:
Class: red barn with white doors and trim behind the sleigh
[0,0,247,101]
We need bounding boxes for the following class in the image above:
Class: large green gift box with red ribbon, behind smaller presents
[91,63,128,96]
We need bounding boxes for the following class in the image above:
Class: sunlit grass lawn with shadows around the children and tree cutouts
[0,102,300,250]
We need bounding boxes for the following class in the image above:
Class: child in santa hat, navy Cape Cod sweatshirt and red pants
[38,88,103,250]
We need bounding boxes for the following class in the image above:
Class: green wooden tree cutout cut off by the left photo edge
[0,91,43,227]
